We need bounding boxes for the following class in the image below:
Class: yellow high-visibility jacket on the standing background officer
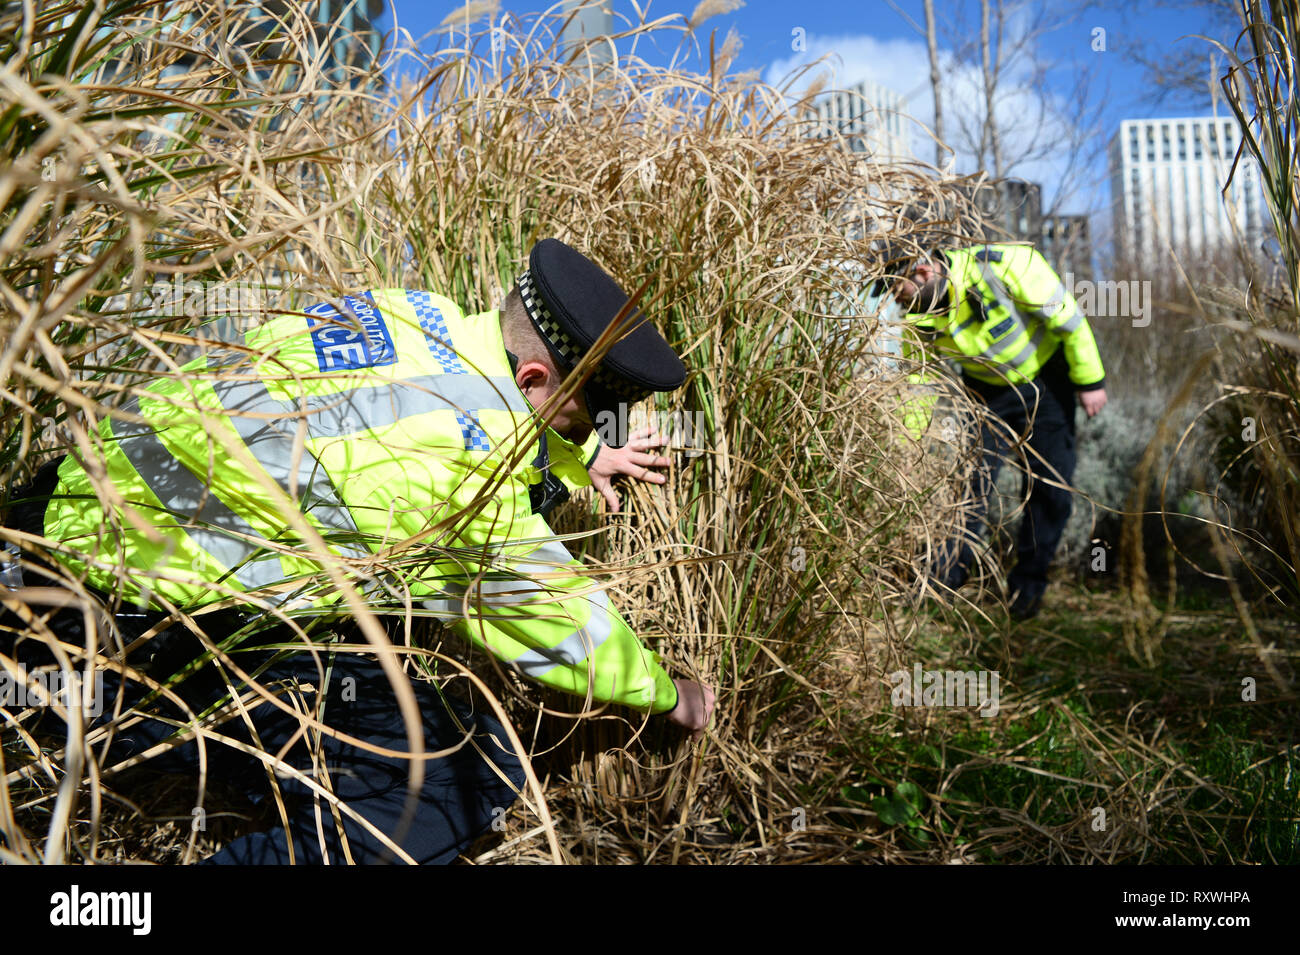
[902,244,1106,434]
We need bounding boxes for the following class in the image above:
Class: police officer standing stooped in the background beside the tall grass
[887,244,1106,620]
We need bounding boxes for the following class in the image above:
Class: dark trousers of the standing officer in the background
[936,348,1075,599]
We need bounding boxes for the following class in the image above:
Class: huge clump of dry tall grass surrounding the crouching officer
[0,3,977,861]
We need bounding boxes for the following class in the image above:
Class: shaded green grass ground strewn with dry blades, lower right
[814,587,1300,863]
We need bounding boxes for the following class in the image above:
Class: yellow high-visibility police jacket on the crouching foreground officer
[46,290,676,712]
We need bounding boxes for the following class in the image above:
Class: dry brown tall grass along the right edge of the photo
[1107,0,1300,670]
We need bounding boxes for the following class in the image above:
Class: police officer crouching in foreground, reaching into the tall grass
[0,239,714,864]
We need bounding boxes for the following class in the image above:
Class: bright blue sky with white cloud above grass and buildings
[380,0,1237,220]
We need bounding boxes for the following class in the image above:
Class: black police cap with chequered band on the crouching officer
[517,239,686,446]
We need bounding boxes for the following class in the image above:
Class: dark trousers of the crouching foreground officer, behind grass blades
[0,468,524,865]
